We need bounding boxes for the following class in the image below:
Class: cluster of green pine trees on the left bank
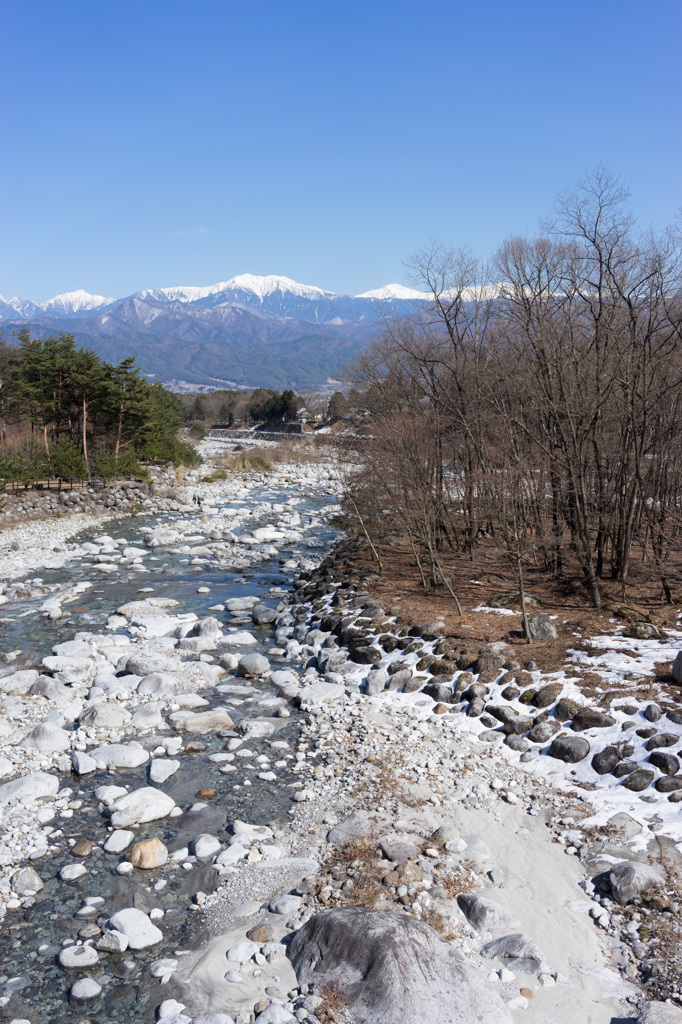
[0,328,198,483]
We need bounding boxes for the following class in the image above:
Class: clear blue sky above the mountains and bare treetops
[0,0,682,300]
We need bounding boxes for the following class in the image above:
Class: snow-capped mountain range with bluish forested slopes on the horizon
[0,274,428,390]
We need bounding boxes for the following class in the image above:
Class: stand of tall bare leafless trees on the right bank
[342,171,682,607]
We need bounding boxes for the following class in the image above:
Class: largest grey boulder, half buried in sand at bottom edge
[288,907,512,1024]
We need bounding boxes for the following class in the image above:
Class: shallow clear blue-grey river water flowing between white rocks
[0,477,334,1024]
